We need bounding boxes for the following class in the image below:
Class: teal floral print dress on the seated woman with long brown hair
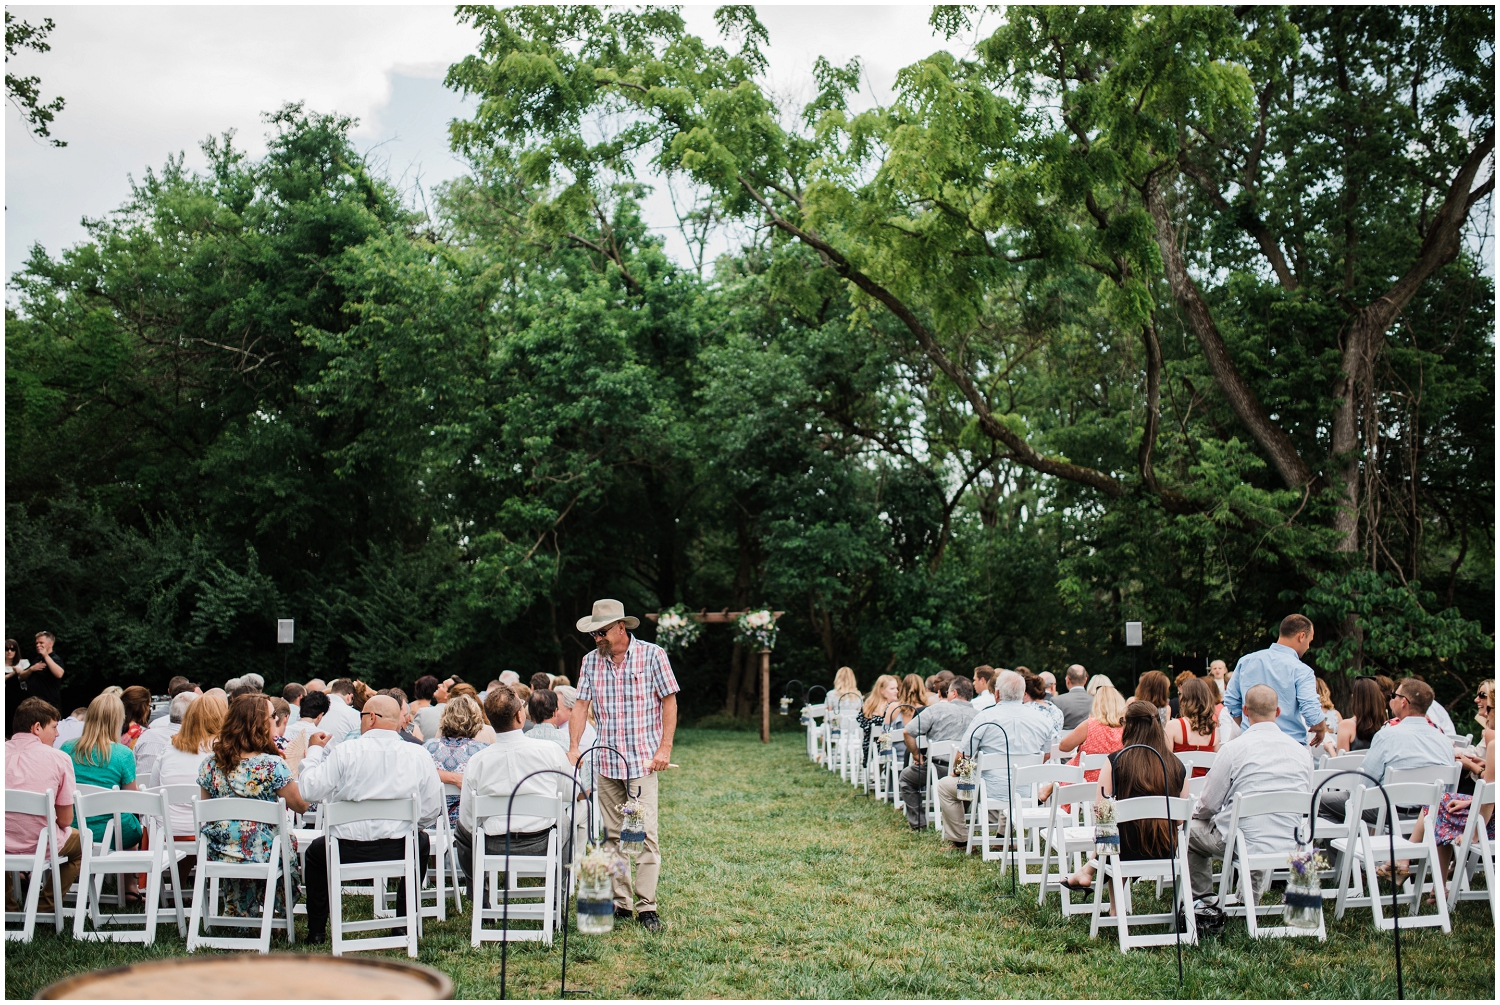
[198,753,302,918]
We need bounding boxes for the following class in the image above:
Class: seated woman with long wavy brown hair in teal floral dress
[198,695,308,918]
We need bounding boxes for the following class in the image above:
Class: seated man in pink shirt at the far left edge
[5,698,84,914]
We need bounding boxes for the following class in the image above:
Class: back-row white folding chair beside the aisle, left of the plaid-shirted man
[470,792,567,948]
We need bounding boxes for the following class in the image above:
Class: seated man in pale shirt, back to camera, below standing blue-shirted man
[1179,690,1313,902]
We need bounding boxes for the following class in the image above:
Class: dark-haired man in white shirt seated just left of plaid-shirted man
[455,684,573,897]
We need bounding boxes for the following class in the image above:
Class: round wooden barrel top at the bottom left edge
[38,953,453,1001]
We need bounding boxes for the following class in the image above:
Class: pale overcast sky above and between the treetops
[5,5,957,278]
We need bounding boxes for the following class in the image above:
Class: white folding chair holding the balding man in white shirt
[323,795,422,960]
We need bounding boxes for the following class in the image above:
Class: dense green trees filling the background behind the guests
[6,6,1494,716]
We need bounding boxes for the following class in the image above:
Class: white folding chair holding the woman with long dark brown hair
[1089,795,1199,953]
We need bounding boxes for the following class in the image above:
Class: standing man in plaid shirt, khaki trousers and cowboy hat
[567,600,681,932]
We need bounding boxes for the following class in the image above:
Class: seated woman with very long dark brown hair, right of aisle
[1062,702,1190,914]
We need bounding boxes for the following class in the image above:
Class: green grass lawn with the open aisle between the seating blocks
[6,731,1496,999]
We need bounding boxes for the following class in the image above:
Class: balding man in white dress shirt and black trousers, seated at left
[297,695,447,944]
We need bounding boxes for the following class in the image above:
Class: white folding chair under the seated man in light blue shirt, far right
[1329,782,1452,933]
